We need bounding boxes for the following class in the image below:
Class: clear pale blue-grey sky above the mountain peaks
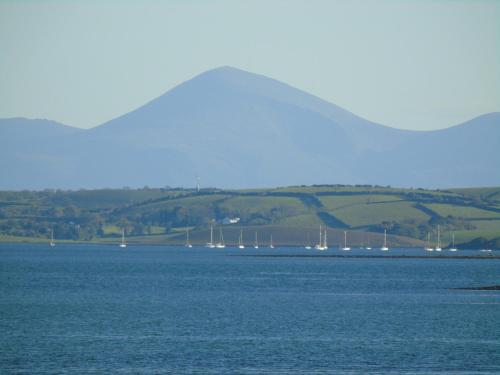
[0,0,500,130]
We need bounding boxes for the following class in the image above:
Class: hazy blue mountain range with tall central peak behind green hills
[0,67,500,189]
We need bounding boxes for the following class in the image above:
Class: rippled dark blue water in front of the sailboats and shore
[0,245,500,374]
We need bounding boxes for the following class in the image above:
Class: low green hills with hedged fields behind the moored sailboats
[0,185,500,249]
